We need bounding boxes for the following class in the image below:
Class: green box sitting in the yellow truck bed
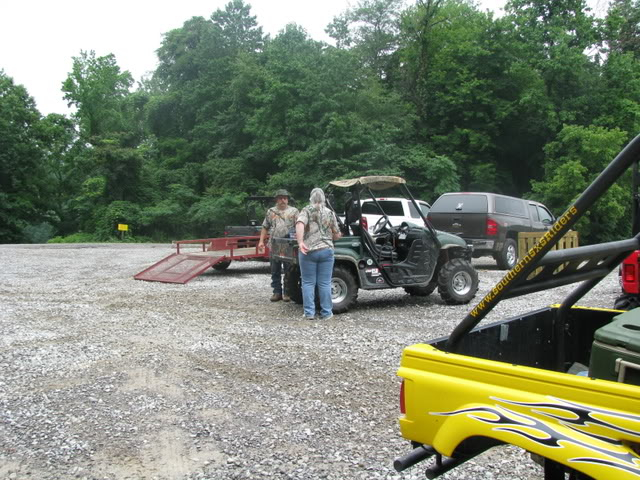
[589,308,640,385]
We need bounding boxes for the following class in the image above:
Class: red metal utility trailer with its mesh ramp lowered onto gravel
[133,236,269,284]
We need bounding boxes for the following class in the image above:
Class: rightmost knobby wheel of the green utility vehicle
[438,258,478,305]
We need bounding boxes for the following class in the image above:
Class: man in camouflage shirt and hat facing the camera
[258,189,298,302]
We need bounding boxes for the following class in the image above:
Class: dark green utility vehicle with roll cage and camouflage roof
[272,176,478,313]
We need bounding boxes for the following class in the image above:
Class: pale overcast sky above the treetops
[0,0,602,115]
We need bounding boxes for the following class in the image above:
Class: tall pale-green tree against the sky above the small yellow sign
[63,52,147,239]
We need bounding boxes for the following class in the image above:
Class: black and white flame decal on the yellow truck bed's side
[430,397,640,477]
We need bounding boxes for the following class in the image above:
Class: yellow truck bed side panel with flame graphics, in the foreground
[398,316,640,480]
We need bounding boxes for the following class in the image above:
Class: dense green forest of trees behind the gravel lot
[0,0,640,243]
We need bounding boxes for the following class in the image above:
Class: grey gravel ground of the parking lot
[0,244,618,480]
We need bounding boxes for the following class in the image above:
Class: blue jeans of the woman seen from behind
[298,248,334,317]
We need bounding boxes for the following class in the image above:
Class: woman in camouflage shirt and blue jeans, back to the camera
[296,188,341,320]
